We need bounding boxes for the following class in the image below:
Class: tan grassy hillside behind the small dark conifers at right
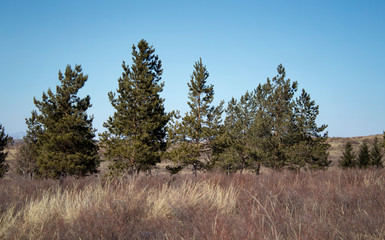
[326,134,383,166]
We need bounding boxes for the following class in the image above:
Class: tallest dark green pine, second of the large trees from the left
[100,40,171,175]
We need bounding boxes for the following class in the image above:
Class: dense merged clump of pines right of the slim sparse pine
[214,65,330,174]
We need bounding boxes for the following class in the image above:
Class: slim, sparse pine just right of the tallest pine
[168,59,223,176]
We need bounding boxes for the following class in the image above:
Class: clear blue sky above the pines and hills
[0,0,385,137]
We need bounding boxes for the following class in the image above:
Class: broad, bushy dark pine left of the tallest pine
[31,65,99,178]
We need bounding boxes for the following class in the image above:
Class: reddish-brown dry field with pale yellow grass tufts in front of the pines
[0,169,385,239]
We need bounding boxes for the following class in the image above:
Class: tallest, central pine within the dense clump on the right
[255,65,298,169]
